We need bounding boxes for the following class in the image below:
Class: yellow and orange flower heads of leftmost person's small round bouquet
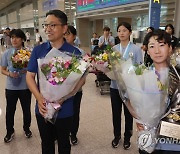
[11,49,31,69]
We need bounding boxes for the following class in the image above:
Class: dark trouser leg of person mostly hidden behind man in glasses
[71,91,82,136]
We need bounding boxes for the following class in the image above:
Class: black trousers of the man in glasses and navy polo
[36,114,72,154]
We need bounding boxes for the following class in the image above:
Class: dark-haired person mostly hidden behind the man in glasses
[64,25,85,145]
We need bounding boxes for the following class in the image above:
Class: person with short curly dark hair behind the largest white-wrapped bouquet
[137,30,180,154]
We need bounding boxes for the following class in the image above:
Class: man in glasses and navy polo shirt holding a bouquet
[26,10,81,154]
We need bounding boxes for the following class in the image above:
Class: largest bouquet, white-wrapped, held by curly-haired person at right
[112,59,168,153]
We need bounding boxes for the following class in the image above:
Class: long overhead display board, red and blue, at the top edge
[76,0,148,13]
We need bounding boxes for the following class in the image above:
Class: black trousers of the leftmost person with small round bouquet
[5,89,31,133]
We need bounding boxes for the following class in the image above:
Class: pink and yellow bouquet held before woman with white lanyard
[91,46,121,80]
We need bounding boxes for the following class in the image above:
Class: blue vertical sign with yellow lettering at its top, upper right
[149,0,161,29]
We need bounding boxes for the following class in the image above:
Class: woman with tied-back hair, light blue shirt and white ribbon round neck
[110,22,142,150]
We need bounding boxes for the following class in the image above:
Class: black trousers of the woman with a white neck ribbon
[110,88,133,140]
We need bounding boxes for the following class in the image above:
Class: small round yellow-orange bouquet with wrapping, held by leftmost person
[9,48,31,86]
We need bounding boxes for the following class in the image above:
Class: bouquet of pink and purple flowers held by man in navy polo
[38,48,88,123]
